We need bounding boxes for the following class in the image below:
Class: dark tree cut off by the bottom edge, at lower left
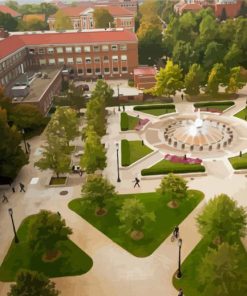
[8,270,60,296]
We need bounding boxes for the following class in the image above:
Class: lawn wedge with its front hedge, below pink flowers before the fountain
[141,159,205,176]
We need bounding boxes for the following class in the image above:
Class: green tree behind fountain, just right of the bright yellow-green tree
[184,64,205,96]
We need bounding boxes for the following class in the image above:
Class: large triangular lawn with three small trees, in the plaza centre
[69,190,204,257]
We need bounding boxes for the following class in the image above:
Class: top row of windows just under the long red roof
[37,44,127,54]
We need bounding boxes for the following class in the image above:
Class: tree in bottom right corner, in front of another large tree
[198,243,247,296]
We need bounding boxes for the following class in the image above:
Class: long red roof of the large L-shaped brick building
[0,29,137,59]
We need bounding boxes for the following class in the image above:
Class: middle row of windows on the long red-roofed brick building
[39,55,127,65]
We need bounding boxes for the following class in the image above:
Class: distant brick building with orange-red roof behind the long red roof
[47,3,135,32]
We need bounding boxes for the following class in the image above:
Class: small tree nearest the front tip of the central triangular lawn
[117,198,155,240]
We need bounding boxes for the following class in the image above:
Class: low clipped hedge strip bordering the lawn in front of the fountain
[141,164,205,176]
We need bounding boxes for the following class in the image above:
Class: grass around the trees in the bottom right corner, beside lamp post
[173,239,247,296]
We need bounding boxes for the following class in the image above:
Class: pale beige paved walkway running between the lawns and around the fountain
[0,88,247,296]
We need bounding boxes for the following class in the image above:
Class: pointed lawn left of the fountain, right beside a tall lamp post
[121,140,153,166]
